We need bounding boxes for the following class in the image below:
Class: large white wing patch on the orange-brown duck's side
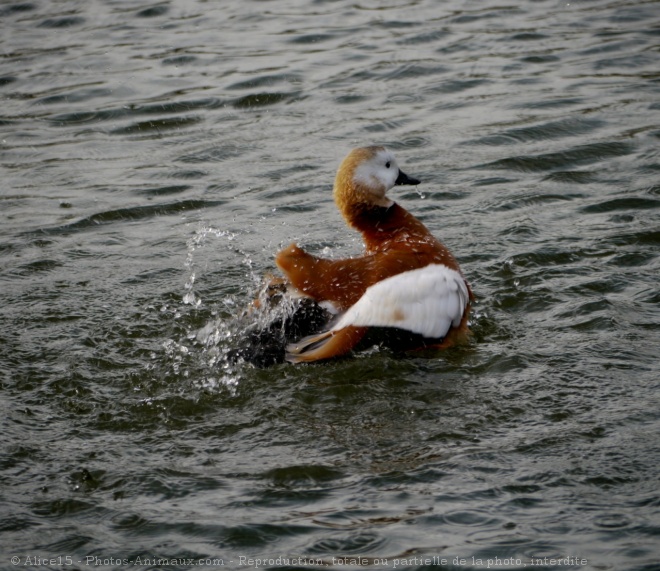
[331,264,469,338]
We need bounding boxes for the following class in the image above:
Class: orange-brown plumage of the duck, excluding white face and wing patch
[275,147,472,361]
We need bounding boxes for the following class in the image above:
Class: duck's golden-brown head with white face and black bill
[334,147,420,219]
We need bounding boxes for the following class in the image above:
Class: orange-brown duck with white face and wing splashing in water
[275,146,474,363]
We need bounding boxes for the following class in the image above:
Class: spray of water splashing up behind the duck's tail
[163,227,329,394]
